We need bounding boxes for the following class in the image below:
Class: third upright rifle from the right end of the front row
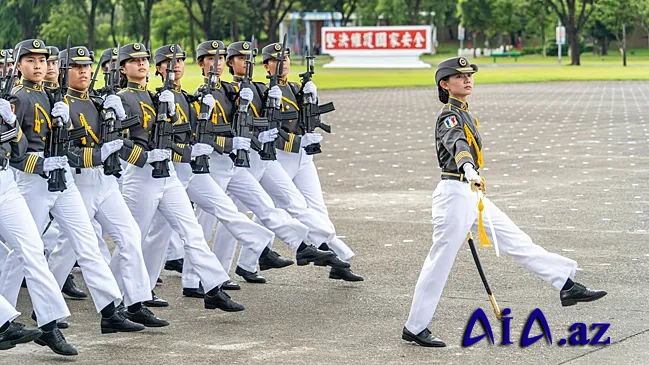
[232,36,268,167]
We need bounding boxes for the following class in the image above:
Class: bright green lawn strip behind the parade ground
[117,50,649,92]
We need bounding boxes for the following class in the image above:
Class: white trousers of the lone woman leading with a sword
[406,180,577,334]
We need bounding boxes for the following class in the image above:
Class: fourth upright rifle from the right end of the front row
[191,64,218,174]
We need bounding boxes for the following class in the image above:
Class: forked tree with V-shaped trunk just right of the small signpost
[545,0,597,66]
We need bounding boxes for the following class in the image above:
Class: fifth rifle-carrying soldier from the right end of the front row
[119,43,244,312]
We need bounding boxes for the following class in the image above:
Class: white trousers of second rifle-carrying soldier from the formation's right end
[219,151,336,268]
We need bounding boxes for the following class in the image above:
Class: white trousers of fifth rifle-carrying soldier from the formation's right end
[122,164,230,292]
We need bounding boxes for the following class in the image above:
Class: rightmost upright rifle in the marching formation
[299,45,335,155]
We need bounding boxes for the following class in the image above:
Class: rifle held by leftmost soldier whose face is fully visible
[45,36,88,191]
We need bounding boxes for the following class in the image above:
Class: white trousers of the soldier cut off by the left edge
[0,170,70,326]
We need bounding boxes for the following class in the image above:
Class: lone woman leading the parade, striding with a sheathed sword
[402,57,606,347]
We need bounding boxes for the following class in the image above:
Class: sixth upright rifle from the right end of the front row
[100,44,140,176]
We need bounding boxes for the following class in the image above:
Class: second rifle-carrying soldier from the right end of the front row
[215,41,363,281]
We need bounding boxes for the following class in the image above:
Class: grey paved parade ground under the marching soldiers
[1,82,649,365]
